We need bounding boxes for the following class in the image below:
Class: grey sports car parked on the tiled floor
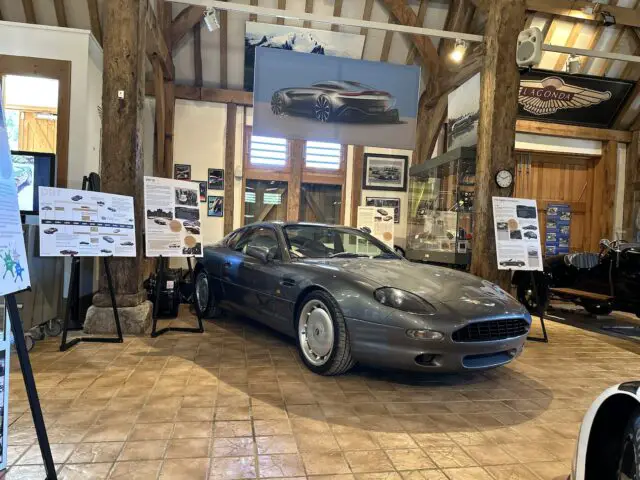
[196,223,531,375]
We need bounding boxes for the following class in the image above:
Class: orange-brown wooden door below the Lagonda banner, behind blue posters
[514,153,599,252]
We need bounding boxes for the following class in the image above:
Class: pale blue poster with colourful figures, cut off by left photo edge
[0,87,31,295]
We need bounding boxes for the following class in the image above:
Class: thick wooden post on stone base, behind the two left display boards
[92,0,147,312]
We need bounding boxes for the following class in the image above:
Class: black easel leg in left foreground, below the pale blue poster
[4,293,58,480]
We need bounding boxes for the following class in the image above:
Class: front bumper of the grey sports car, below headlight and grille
[346,318,526,373]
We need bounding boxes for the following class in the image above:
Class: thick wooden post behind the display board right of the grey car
[471,0,525,287]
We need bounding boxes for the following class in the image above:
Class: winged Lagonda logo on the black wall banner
[518,77,611,116]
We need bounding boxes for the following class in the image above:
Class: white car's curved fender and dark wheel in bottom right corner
[569,381,640,480]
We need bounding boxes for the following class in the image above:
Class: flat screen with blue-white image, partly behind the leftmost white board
[11,151,56,215]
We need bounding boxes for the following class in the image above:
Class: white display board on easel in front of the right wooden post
[493,197,543,270]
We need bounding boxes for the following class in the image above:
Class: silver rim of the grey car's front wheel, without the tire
[298,299,335,366]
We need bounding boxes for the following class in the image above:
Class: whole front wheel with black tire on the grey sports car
[295,290,355,376]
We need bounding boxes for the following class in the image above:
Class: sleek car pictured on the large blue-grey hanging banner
[271,81,400,123]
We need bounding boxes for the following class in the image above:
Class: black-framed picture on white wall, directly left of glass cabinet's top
[362,153,409,192]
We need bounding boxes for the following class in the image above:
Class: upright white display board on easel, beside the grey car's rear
[144,177,202,257]
